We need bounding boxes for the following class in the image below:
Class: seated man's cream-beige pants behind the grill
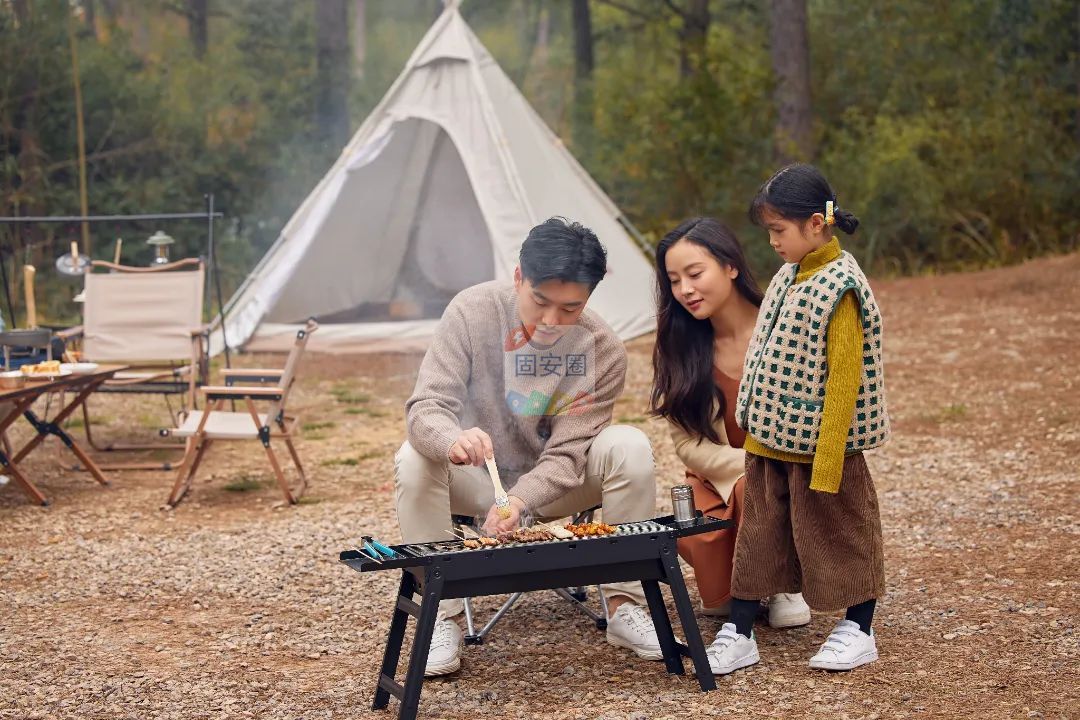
[394,425,657,615]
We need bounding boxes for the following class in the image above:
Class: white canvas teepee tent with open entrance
[214,1,654,352]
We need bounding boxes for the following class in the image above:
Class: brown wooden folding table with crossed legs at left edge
[0,365,124,505]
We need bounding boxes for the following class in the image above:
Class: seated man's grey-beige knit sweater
[405,282,626,510]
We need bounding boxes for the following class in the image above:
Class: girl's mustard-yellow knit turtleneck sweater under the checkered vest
[743,237,863,492]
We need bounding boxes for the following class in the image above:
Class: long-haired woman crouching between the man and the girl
[650,218,810,627]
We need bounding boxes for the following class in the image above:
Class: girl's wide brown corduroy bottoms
[731,452,885,611]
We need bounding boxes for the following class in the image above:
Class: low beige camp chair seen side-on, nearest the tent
[167,320,319,505]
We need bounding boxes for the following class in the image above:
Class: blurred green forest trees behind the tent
[0,0,1080,324]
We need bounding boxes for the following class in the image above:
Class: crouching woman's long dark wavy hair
[649,217,762,443]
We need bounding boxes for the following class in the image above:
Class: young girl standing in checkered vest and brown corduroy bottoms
[708,164,889,675]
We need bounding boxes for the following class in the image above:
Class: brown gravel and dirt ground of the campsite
[0,255,1080,720]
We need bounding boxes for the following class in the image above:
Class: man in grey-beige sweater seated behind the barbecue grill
[394,218,662,676]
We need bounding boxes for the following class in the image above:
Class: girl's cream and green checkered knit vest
[735,253,890,454]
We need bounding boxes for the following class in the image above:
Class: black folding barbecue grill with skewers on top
[340,515,732,720]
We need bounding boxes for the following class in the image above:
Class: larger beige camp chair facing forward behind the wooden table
[62,258,210,470]
